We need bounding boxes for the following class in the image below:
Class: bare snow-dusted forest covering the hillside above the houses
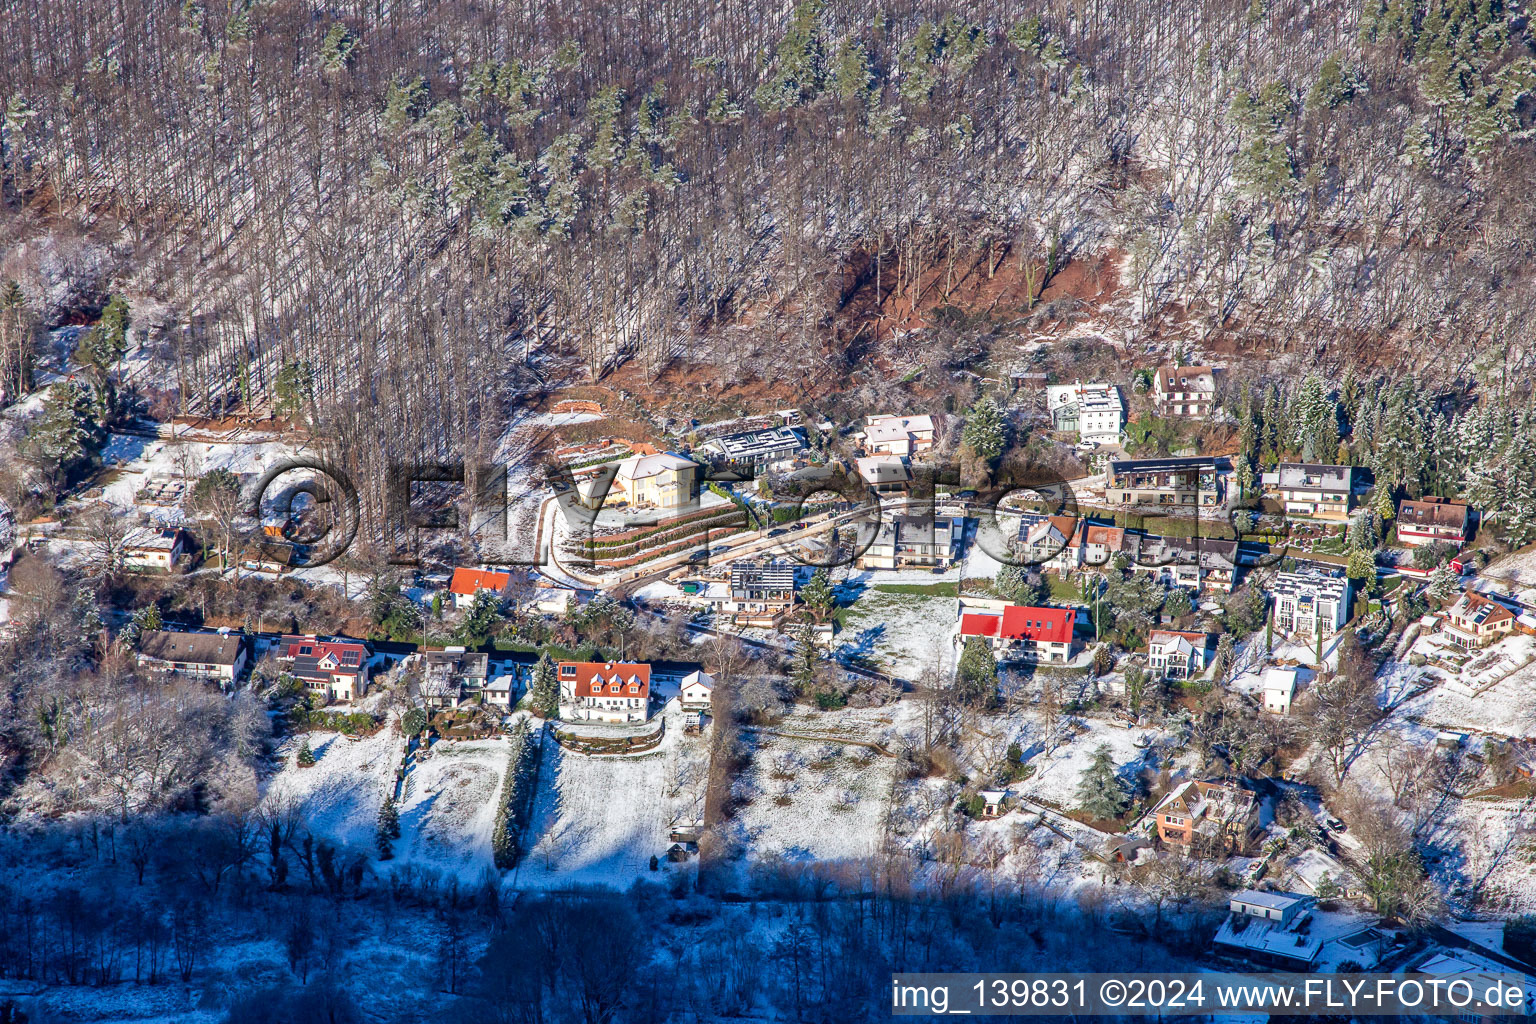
[0,0,1536,525]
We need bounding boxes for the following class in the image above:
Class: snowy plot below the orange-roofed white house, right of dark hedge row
[515,705,708,889]
